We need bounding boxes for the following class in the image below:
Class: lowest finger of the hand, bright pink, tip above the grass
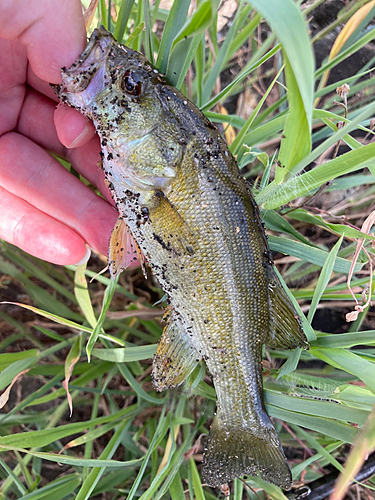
[0,188,87,265]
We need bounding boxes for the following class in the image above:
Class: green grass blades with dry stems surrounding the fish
[0,0,375,500]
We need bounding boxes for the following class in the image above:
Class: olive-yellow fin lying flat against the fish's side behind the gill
[150,191,195,255]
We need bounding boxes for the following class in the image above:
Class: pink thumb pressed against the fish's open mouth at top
[0,0,86,83]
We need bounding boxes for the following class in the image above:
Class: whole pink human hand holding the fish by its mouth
[0,0,117,264]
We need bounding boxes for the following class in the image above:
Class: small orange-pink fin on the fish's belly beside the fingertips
[108,217,144,278]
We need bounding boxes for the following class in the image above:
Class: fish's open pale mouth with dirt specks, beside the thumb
[59,26,115,93]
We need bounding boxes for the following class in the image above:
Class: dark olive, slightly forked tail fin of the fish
[202,416,292,490]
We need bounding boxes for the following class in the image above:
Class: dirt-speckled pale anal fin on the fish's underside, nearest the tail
[152,319,201,391]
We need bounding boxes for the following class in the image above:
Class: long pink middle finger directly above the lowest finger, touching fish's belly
[0,133,117,253]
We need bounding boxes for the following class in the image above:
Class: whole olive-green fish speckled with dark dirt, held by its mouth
[53,27,309,490]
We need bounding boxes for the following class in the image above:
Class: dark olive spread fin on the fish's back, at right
[266,268,309,349]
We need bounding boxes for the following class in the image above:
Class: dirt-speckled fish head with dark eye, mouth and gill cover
[52,27,186,196]
